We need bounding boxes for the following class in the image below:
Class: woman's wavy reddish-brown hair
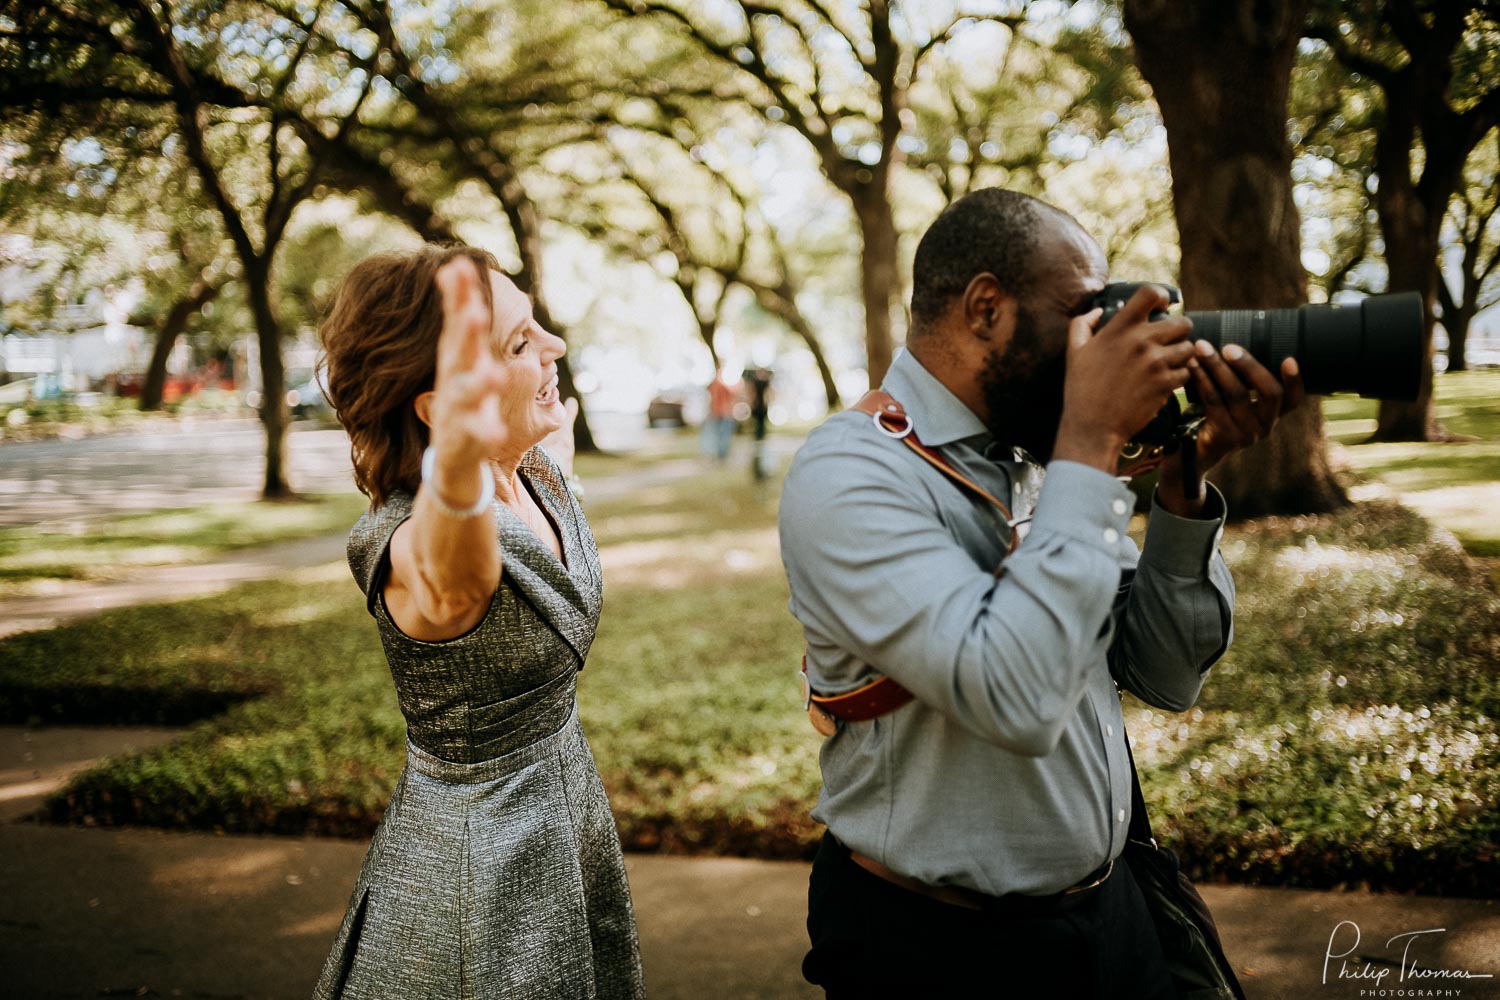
[318,243,500,507]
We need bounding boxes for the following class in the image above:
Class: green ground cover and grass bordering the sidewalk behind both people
[0,458,1500,895]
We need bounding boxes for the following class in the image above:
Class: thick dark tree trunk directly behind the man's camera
[1125,0,1347,517]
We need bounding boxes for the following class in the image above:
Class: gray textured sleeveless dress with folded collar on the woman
[315,448,645,1000]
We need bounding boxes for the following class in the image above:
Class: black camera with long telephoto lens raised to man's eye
[1088,282,1427,402]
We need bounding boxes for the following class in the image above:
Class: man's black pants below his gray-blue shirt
[803,835,1176,1000]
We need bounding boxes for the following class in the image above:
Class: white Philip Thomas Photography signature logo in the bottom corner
[1323,921,1494,1000]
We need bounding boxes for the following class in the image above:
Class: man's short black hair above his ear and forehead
[912,187,1073,334]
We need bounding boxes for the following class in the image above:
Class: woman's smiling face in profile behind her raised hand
[489,271,567,448]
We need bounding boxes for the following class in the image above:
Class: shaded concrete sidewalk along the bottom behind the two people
[0,727,1500,1000]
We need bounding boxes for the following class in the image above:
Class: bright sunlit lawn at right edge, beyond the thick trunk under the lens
[1323,372,1500,558]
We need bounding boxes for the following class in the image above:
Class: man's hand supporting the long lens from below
[1157,340,1304,516]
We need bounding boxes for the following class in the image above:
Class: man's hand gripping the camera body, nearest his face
[1053,285,1200,474]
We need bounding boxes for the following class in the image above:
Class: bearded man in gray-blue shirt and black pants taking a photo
[780,189,1301,1000]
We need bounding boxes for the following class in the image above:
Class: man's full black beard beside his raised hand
[980,309,1068,463]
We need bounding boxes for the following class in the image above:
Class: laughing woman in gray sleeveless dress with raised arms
[315,246,644,1000]
